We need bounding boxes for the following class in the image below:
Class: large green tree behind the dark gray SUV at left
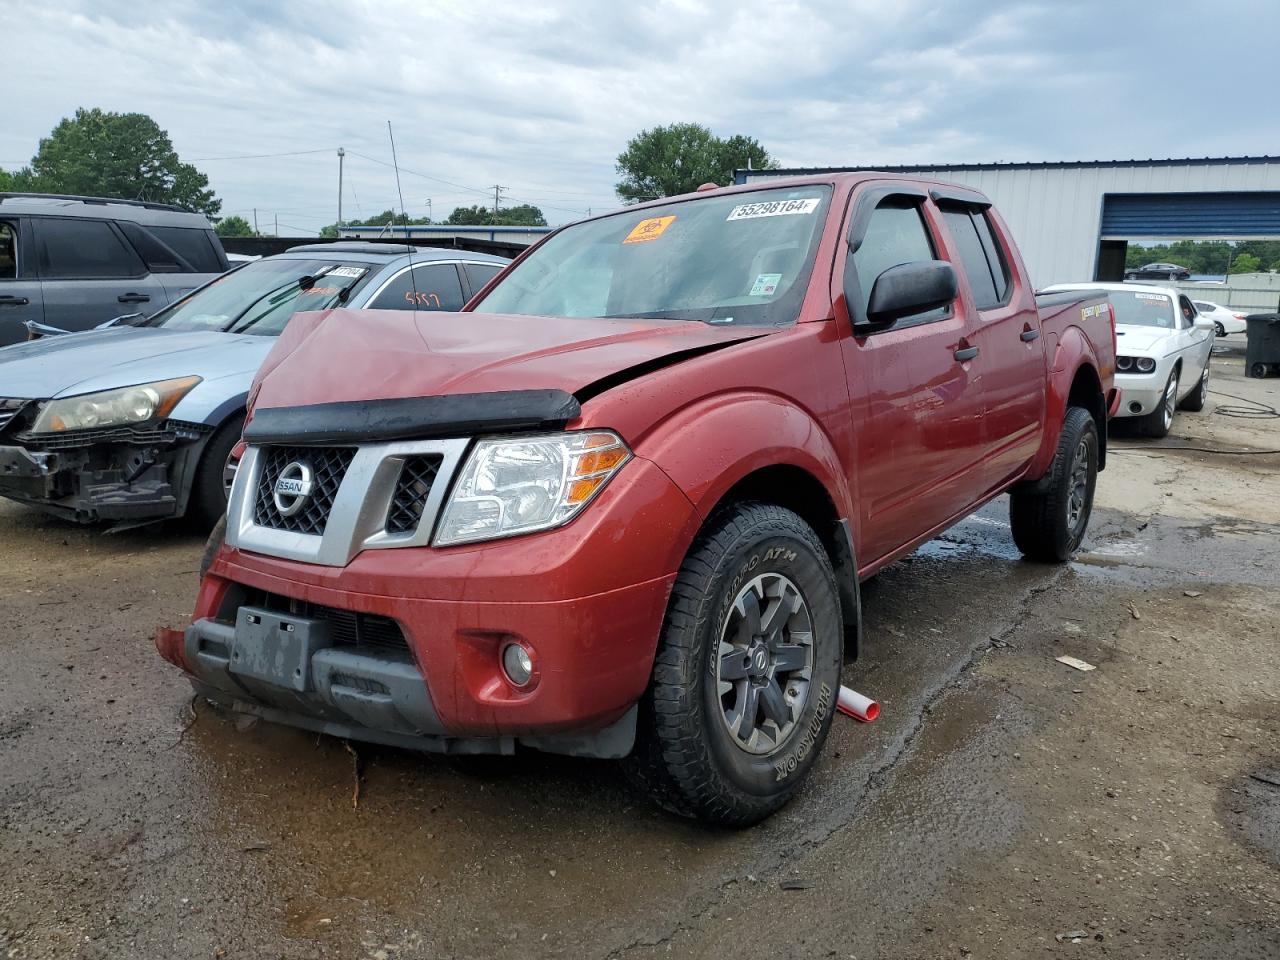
[15,108,221,216]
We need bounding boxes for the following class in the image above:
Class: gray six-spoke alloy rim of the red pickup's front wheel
[716,573,814,754]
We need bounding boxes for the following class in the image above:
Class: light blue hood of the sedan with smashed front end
[0,326,274,399]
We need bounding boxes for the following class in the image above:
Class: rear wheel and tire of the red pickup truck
[1009,407,1098,563]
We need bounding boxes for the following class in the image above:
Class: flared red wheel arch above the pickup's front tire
[636,393,852,520]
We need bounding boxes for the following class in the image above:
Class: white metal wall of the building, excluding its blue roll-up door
[745,161,1280,287]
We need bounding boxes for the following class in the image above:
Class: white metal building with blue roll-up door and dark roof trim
[735,156,1280,287]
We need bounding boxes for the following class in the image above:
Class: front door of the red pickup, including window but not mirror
[837,184,983,564]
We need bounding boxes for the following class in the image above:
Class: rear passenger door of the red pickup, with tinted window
[934,200,1048,489]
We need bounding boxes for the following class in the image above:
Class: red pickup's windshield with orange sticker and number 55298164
[474,184,831,325]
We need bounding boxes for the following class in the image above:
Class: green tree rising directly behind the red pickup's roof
[614,123,777,204]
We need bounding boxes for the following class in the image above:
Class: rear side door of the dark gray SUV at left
[31,216,165,330]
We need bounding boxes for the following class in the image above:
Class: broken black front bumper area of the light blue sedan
[0,420,212,524]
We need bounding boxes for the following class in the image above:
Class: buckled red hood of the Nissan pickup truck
[256,310,762,408]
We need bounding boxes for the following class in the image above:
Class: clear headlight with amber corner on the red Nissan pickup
[435,430,631,547]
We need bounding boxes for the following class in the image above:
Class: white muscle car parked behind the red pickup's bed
[1043,283,1213,436]
